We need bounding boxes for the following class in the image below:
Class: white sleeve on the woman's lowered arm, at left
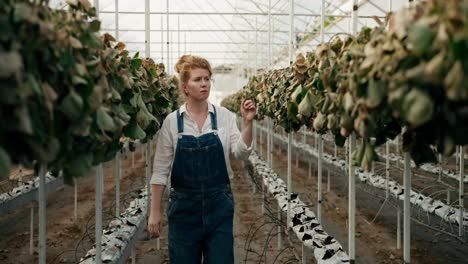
[150,116,174,185]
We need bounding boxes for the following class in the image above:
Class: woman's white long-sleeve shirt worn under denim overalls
[151,103,252,185]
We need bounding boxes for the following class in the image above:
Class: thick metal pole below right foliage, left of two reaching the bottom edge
[348,133,356,263]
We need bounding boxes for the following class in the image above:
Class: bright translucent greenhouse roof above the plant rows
[46,0,406,70]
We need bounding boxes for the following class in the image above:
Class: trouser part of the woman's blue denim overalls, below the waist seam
[167,188,234,264]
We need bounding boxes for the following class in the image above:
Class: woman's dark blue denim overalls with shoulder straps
[167,109,234,264]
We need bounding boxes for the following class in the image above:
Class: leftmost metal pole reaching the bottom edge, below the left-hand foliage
[39,164,47,264]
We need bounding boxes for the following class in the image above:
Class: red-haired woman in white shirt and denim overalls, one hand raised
[148,55,256,264]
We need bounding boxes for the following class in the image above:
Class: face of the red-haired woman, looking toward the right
[184,68,211,101]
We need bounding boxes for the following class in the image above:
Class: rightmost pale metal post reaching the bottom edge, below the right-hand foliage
[403,152,411,263]
